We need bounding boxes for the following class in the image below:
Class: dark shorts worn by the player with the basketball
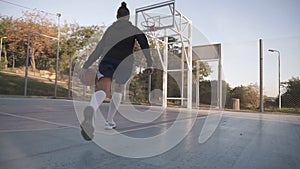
[97,60,133,84]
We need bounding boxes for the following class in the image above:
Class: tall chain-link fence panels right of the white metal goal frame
[218,37,300,112]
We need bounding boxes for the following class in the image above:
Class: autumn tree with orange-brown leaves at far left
[1,11,57,70]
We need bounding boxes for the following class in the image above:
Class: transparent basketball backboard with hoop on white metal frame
[135,0,175,32]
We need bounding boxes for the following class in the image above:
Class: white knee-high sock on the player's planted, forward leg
[106,92,122,122]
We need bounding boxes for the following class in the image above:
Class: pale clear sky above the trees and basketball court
[0,0,300,96]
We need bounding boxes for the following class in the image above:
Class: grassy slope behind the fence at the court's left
[0,73,68,97]
